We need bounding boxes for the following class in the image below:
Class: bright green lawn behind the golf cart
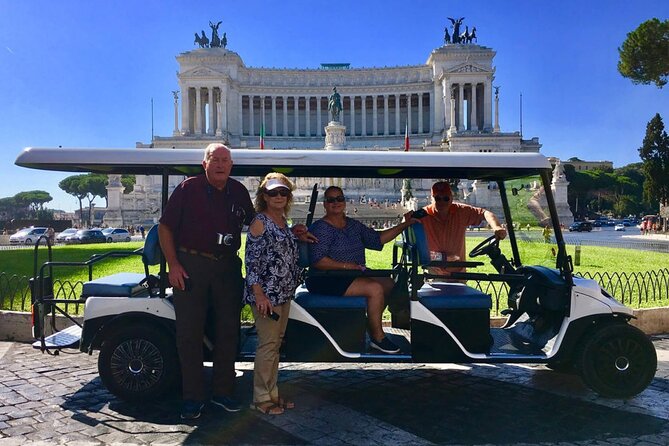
[0,232,669,310]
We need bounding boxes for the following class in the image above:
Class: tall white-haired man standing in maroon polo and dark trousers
[158,144,255,419]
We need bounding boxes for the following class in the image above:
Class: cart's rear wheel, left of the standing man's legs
[98,325,179,401]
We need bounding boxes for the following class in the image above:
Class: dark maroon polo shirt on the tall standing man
[160,174,255,254]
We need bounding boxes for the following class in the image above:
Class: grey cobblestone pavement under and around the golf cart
[0,336,669,446]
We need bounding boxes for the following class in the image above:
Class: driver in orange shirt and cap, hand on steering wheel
[420,181,506,274]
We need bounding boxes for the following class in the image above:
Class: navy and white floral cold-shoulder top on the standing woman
[244,213,300,305]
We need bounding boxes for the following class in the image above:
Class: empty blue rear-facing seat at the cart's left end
[81,225,161,298]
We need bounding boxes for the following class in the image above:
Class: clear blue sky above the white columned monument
[0,0,669,210]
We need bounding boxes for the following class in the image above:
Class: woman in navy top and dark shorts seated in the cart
[306,186,418,353]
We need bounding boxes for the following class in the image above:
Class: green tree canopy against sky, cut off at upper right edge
[618,18,669,88]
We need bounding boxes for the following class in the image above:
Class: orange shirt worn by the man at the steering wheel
[421,203,485,272]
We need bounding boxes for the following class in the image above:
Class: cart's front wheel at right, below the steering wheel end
[579,324,657,398]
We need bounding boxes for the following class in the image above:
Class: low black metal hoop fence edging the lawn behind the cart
[0,268,669,315]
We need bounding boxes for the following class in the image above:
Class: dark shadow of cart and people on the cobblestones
[61,364,669,444]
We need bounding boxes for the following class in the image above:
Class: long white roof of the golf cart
[16,147,551,180]
